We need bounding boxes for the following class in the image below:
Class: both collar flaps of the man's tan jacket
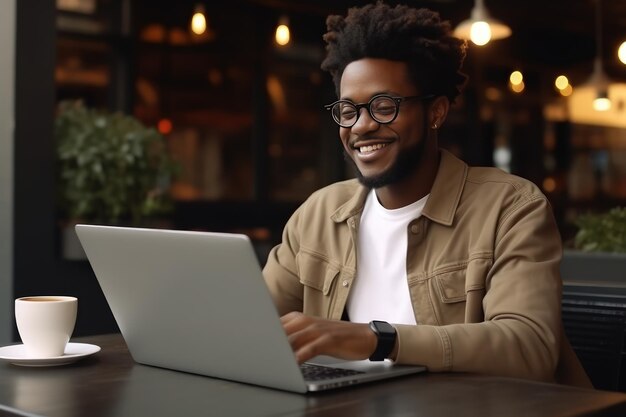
[331,149,468,226]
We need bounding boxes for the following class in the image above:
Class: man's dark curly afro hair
[322,1,467,102]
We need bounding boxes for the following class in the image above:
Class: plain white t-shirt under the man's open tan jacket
[347,190,428,324]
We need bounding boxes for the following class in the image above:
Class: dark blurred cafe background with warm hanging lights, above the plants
[54,0,626,240]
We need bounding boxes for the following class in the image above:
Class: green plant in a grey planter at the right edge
[561,207,626,284]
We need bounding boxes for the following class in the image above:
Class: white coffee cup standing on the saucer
[15,295,78,358]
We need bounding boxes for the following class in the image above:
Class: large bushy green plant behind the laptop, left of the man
[54,101,175,259]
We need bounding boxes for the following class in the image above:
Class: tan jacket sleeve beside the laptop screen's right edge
[263,208,304,316]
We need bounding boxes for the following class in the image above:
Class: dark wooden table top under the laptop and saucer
[0,334,626,417]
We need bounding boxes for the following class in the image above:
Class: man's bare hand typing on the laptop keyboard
[280,312,378,363]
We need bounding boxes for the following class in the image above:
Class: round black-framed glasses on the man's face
[324,94,435,127]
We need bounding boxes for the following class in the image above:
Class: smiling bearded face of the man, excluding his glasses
[339,58,427,188]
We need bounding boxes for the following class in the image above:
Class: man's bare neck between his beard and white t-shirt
[376,148,440,210]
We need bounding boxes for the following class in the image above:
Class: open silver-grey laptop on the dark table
[76,224,425,393]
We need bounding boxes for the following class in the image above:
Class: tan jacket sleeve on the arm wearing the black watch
[396,194,562,381]
